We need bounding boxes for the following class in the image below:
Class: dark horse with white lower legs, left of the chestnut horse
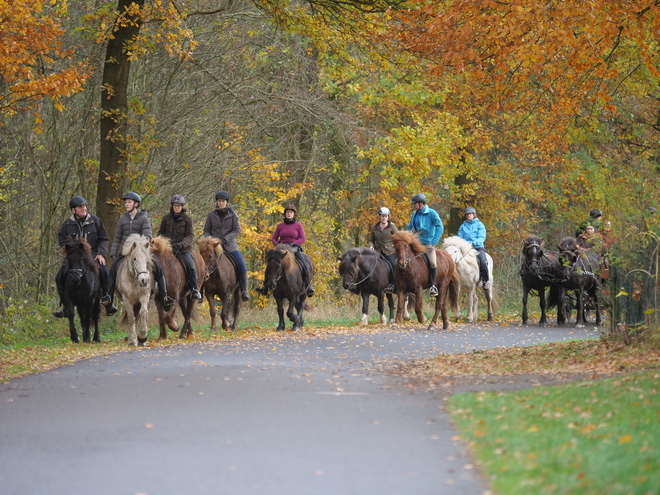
[339,248,394,325]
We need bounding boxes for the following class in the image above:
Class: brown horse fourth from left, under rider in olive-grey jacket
[197,237,242,332]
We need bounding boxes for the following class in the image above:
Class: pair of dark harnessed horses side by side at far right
[520,235,602,327]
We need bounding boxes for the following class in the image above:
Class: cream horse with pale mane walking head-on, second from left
[116,234,155,346]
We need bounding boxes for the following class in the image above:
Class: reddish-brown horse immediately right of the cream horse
[151,236,205,340]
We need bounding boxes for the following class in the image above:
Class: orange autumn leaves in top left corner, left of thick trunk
[0,0,89,119]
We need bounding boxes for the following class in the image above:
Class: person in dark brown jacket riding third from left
[158,194,202,299]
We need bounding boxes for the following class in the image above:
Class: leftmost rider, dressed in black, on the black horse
[53,196,117,318]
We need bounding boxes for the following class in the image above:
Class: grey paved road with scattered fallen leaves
[0,325,598,495]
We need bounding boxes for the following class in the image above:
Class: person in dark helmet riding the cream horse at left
[105,192,174,311]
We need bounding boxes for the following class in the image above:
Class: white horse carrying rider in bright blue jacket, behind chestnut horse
[442,236,493,323]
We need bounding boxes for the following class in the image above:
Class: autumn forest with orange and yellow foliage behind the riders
[0,0,660,318]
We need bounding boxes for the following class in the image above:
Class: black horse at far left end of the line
[62,239,101,344]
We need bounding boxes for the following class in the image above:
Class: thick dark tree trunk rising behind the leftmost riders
[96,0,145,248]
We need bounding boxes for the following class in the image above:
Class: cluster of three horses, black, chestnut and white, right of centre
[339,231,494,331]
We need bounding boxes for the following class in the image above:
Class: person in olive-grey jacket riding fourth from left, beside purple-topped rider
[204,191,250,301]
